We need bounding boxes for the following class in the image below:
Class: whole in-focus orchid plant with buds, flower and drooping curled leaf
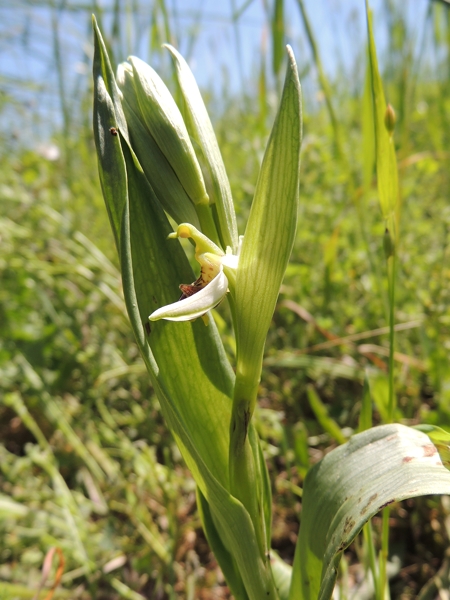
[94,11,450,600]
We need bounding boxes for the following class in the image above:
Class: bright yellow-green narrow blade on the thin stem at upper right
[366,0,398,237]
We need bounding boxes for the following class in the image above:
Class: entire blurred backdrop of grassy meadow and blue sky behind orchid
[0,0,450,600]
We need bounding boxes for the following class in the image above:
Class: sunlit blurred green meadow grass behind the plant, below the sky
[0,2,450,599]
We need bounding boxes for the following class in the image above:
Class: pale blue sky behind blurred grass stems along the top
[0,0,429,144]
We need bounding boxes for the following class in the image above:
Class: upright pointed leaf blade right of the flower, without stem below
[235,47,302,426]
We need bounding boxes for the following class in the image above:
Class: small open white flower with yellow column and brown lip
[149,223,241,321]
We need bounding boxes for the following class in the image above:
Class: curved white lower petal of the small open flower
[149,270,228,321]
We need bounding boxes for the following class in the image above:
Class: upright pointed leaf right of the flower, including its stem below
[229,48,301,576]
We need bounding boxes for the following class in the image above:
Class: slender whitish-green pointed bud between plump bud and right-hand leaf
[166,45,238,252]
